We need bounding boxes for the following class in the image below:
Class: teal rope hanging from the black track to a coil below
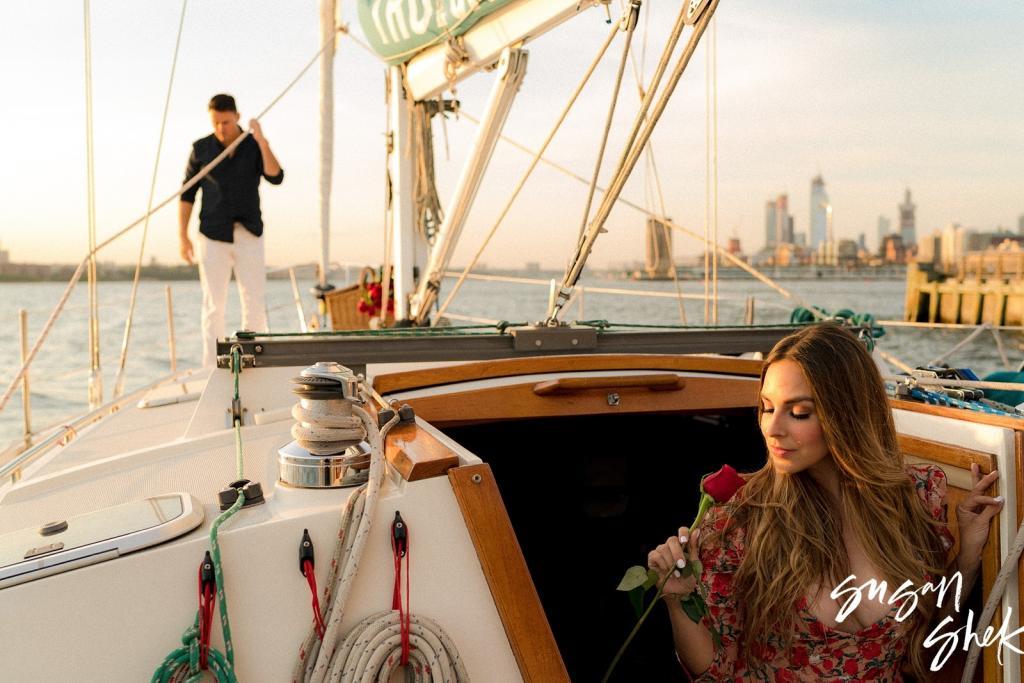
[151,346,246,683]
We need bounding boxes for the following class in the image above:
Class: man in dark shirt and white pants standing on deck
[178,94,285,368]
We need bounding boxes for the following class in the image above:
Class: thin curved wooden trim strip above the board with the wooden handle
[374,353,762,395]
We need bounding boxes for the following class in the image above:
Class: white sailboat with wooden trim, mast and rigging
[0,0,1024,682]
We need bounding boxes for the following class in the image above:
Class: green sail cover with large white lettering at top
[358,0,516,65]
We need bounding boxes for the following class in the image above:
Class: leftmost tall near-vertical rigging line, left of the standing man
[82,0,103,408]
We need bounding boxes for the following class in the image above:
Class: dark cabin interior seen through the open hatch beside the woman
[444,409,765,681]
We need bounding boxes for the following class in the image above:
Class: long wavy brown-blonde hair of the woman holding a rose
[731,324,945,680]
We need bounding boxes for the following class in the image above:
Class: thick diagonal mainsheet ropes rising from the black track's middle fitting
[546,0,719,325]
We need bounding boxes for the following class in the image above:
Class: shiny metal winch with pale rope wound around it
[278,361,370,488]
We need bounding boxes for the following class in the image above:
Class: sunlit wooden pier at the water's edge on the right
[903,250,1024,326]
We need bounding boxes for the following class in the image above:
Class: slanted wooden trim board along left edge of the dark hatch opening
[447,463,569,683]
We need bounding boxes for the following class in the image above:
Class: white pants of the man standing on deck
[199,223,267,368]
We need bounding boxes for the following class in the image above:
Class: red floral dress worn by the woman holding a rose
[695,465,953,683]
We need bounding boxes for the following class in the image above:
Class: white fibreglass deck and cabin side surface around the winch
[0,368,519,681]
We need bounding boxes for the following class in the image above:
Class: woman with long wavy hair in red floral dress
[648,325,1002,681]
